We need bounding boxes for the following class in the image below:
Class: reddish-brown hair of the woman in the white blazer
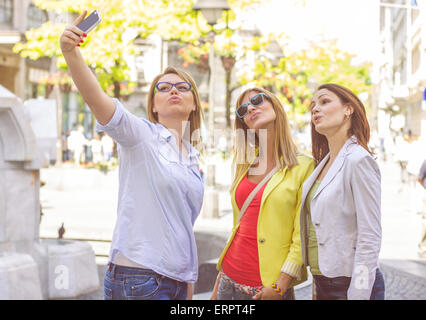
[311,83,372,164]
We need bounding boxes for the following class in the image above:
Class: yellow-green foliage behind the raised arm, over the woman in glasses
[14,0,268,95]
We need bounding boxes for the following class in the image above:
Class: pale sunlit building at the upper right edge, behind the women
[379,0,426,136]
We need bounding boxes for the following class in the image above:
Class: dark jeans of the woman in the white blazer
[314,269,385,300]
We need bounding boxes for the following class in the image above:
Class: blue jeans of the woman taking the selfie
[104,263,187,300]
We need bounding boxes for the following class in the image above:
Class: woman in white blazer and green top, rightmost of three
[300,84,385,300]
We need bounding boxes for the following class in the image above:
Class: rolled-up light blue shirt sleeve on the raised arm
[95,98,155,147]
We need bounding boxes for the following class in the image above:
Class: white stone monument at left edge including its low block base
[0,86,99,299]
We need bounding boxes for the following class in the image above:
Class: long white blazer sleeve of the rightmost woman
[348,155,382,300]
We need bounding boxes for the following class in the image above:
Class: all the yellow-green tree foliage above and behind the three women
[14,0,370,129]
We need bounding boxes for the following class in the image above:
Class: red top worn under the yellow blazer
[222,175,266,287]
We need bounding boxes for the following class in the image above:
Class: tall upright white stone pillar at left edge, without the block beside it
[0,86,43,299]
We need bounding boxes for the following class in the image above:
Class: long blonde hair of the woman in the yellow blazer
[231,87,298,190]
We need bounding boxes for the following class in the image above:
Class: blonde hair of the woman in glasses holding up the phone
[147,67,202,147]
